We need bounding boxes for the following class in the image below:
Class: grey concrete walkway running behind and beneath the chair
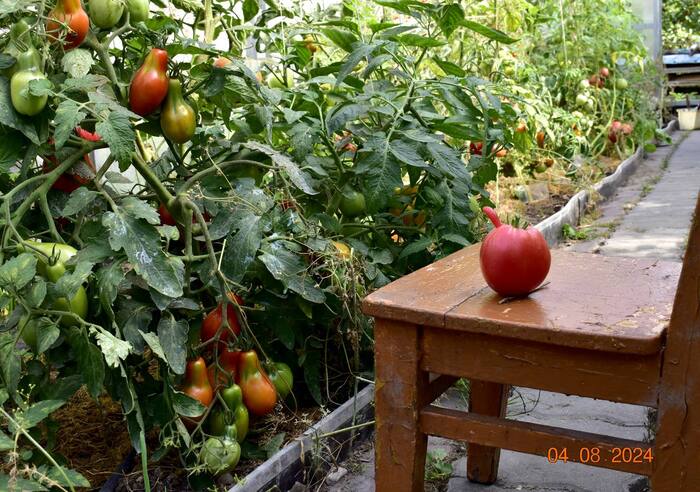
[325,132,700,492]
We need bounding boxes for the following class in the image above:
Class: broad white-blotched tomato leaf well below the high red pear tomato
[102,210,185,297]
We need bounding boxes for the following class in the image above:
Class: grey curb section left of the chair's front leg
[228,384,374,492]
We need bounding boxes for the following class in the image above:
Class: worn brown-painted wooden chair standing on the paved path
[364,193,700,492]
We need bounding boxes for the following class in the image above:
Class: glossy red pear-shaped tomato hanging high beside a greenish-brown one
[129,48,170,116]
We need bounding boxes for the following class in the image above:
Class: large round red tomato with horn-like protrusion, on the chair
[479,207,551,296]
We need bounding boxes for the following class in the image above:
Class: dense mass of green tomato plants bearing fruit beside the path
[0,0,653,488]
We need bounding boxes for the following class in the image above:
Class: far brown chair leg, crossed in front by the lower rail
[467,379,509,484]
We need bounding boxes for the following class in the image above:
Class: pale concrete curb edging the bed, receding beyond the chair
[535,120,678,247]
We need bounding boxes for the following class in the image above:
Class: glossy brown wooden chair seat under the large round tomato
[363,244,682,355]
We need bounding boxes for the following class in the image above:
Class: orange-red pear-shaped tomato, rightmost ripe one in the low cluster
[238,350,277,416]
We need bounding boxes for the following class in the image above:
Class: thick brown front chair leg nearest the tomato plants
[374,319,428,492]
